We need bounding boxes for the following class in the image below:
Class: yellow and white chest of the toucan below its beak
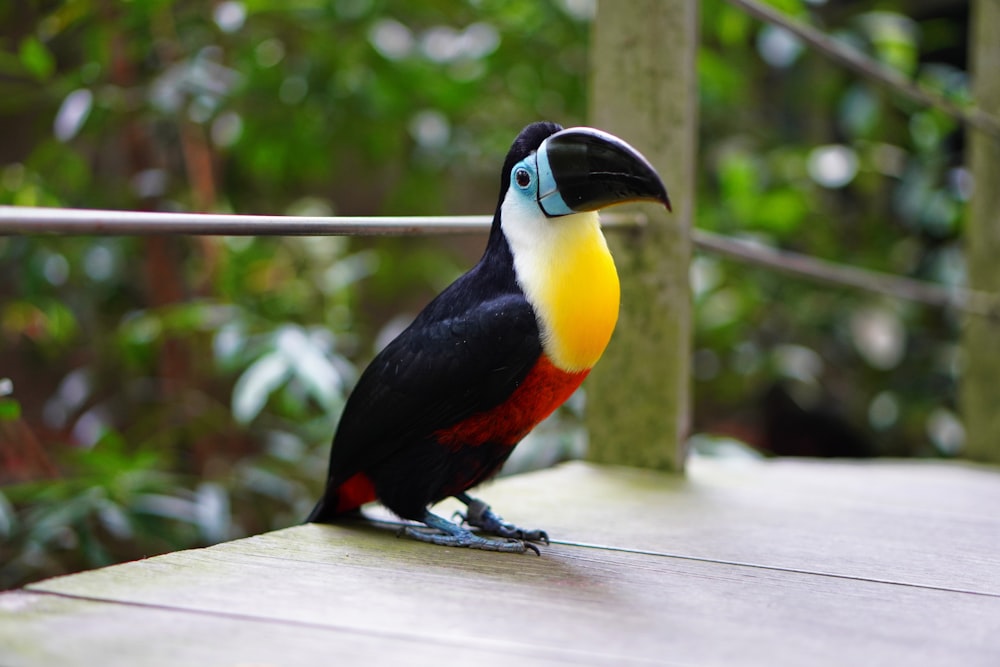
[515,214,620,372]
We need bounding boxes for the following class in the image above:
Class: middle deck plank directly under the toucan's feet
[9,526,1000,665]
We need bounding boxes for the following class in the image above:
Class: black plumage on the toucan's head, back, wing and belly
[308,123,562,522]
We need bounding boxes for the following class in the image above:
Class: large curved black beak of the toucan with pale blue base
[536,127,671,217]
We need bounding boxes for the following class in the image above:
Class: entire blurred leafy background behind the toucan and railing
[0,0,970,588]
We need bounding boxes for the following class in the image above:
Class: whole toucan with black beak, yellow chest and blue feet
[308,122,670,554]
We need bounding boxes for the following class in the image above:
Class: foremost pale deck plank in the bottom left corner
[0,592,600,667]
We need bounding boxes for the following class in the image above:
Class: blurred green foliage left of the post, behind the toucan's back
[0,0,589,586]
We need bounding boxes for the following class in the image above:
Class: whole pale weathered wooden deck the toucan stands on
[0,460,1000,667]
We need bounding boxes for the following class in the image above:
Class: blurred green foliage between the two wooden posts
[692,1,969,455]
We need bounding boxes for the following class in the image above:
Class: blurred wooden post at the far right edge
[961,0,1000,462]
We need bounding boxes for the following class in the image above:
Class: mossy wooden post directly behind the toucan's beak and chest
[586,0,698,471]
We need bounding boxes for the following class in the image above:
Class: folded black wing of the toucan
[328,294,541,488]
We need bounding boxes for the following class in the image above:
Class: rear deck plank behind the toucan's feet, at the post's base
[450,458,1000,594]
